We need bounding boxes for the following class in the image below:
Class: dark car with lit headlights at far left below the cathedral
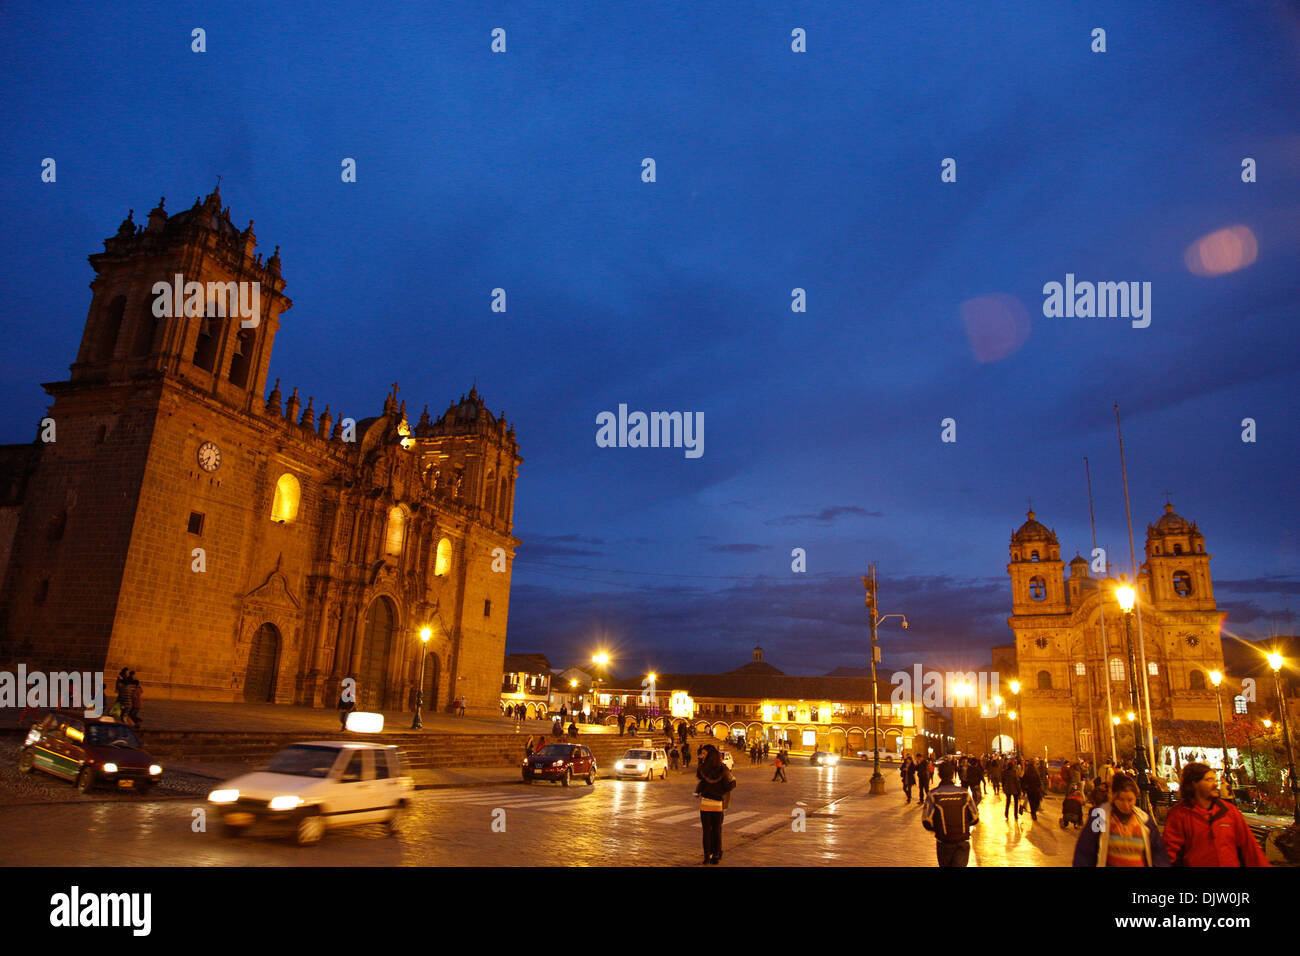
[18,713,163,793]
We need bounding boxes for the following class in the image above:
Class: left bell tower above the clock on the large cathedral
[70,189,293,410]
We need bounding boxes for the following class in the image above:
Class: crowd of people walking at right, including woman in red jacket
[915,754,1269,866]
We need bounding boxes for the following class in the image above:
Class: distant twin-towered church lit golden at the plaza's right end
[1001,503,1236,766]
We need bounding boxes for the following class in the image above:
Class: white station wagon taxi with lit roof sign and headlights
[208,740,415,845]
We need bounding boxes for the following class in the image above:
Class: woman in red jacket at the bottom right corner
[1165,763,1269,866]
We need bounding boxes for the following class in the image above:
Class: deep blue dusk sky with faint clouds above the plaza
[0,0,1300,674]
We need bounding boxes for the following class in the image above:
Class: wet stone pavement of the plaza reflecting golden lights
[0,765,1075,866]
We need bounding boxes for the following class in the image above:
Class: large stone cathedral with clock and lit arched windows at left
[0,190,523,714]
